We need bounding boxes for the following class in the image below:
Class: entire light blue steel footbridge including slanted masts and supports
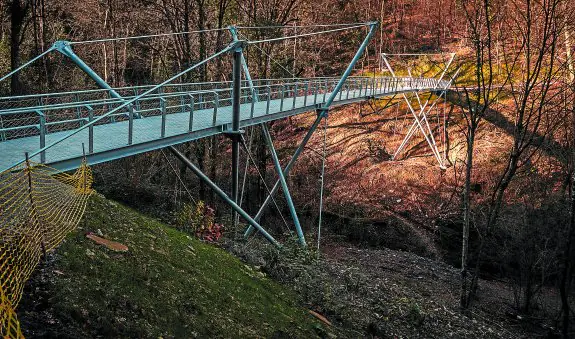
[0,22,460,246]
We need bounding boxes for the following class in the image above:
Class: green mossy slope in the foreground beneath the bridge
[18,195,327,338]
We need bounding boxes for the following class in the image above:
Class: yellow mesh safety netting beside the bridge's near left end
[0,161,93,338]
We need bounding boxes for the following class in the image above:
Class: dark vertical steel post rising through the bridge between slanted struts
[232,47,242,229]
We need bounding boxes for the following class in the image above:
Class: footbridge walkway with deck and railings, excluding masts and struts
[0,77,447,171]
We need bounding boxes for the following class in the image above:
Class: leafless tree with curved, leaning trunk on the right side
[470,0,563,308]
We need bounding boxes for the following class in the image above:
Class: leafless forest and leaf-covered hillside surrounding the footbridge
[0,0,575,338]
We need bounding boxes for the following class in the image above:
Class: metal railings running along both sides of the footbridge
[0,77,447,162]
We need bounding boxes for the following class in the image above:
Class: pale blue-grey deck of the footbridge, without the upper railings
[0,78,444,171]
